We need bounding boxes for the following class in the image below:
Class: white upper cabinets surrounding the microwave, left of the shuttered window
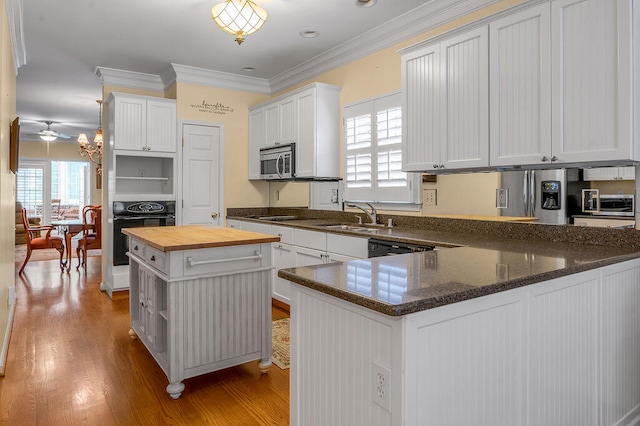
[249,83,341,179]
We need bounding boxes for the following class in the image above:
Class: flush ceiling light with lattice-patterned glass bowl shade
[211,0,267,44]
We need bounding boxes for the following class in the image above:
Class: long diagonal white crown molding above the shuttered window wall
[269,0,499,93]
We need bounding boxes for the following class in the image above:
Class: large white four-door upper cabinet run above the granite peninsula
[401,0,640,173]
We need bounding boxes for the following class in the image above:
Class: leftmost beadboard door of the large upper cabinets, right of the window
[402,44,444,171]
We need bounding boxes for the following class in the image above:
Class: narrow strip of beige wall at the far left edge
[0,0,16,374]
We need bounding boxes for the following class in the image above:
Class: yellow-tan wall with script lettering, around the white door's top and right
[176,83,269,208]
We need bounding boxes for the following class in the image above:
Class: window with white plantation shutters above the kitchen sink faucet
[344,93,420,208]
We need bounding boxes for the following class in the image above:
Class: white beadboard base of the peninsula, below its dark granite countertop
[290,259,640,426]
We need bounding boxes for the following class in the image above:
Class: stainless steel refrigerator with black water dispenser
[496,169,588,225]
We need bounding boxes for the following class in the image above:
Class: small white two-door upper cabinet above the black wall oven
[107,93,177,153]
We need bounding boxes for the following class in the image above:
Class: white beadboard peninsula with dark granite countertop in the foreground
[279,240,640,426]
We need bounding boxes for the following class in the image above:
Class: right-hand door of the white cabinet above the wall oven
[147,99,177,153]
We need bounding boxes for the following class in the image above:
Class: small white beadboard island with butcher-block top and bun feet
[122,225,279,399]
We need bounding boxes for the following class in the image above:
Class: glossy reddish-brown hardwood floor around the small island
[0,257,289,426]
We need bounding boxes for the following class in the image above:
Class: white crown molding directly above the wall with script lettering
[170,63,272,94]
